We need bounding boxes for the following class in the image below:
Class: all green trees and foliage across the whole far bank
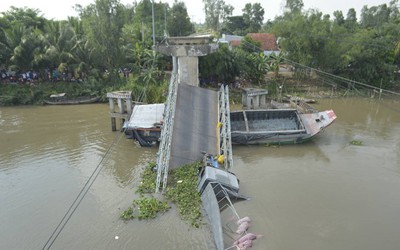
[0,0,400,105]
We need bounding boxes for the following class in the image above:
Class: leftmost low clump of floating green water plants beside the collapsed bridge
[121,197,170,220]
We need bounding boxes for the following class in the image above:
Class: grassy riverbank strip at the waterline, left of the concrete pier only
[0,75,168,106]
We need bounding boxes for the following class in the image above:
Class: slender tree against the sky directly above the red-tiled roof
[243,3,265,33]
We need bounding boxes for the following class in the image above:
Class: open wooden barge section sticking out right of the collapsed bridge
[230,109,337,144]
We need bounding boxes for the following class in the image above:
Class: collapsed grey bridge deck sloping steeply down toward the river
[169,84,218,169]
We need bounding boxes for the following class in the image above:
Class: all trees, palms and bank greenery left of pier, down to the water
[0,0,189,105]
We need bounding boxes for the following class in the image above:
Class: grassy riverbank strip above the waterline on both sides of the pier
[0,76,396,106]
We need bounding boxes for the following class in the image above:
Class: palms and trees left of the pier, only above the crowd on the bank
[0,0,194,74]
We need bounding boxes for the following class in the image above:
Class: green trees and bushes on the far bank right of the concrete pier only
[200,0,400,88]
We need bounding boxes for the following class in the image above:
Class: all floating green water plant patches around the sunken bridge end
[121,162,202,228]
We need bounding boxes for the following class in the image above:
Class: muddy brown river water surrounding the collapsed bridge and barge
[0,99,400,250]
